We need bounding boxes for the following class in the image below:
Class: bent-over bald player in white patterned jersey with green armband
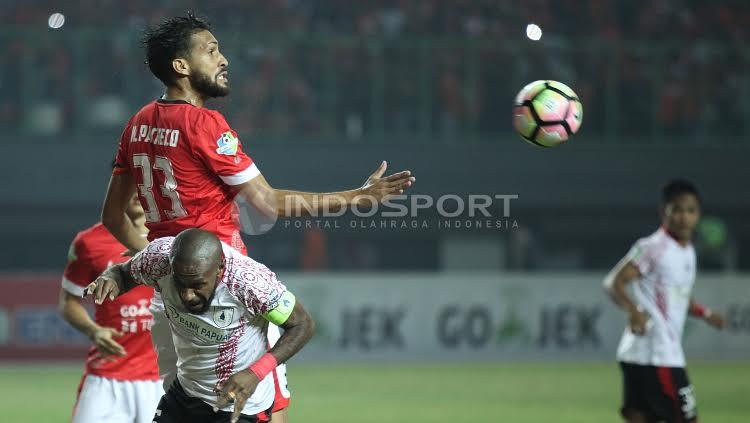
[87,229,314,423]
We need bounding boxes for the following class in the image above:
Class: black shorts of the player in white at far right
[620,362,698,423]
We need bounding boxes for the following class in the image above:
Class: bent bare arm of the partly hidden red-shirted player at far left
[58,289,125,357]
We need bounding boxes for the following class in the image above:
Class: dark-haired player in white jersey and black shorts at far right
[604,180,724,423]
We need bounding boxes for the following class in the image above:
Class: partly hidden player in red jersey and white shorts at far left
[60,196,164,423]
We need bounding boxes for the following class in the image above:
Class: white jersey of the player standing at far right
[617,228,696,367]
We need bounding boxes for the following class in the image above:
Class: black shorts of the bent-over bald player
[154,379,273,423]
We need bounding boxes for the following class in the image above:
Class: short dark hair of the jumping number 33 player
[141,11,211,85]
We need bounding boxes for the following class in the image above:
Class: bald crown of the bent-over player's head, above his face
[170,228,222,276]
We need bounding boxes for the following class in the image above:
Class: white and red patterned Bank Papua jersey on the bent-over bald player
[130,237,286,415]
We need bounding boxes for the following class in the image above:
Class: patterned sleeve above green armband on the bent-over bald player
[227,258,293,323]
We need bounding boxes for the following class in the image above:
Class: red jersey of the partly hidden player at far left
[62,223,159,380]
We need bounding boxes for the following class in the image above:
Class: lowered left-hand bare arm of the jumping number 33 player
[102,173,148,251]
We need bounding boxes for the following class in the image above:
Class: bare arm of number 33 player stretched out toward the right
[237,161,416,217]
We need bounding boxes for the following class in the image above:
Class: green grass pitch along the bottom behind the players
[0,362,750,423]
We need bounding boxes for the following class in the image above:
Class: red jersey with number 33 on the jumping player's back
[115,100,260,252]
